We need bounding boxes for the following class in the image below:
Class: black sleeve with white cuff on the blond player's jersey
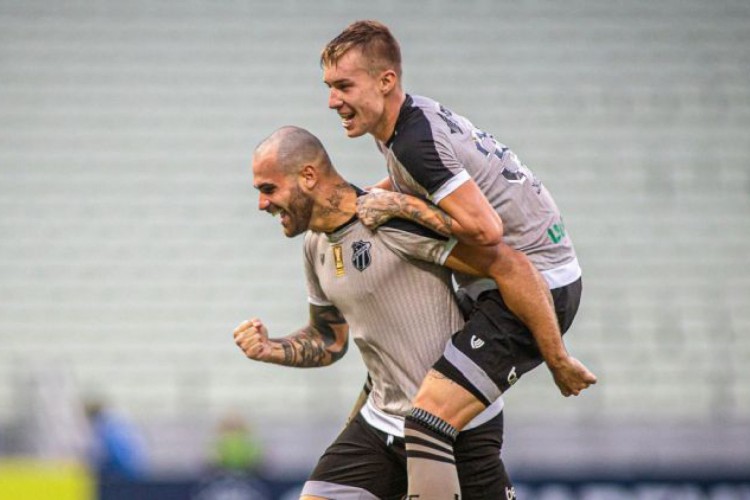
[393,120,470,205]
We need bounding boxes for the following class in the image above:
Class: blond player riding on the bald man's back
[321,21,596,498]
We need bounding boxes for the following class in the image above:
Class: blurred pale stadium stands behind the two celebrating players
[0,0,750,500]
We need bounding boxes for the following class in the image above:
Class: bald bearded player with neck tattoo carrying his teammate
[234,127,513,500]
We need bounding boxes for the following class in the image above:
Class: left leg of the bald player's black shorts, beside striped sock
[305,415,407,500]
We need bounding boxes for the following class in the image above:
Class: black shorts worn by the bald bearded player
[303,412,512,500]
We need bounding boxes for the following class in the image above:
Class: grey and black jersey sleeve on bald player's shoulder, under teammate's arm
[377,223,458,265]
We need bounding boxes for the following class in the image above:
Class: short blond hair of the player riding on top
[320,21,401,78]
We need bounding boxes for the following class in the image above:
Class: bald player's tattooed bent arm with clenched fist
[234,304,349,368]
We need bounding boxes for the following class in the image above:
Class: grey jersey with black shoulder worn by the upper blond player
[377,95,581,288]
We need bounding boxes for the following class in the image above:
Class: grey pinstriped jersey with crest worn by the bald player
[304,211,502,435]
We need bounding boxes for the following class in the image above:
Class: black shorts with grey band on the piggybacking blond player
[433,278,582,405]
